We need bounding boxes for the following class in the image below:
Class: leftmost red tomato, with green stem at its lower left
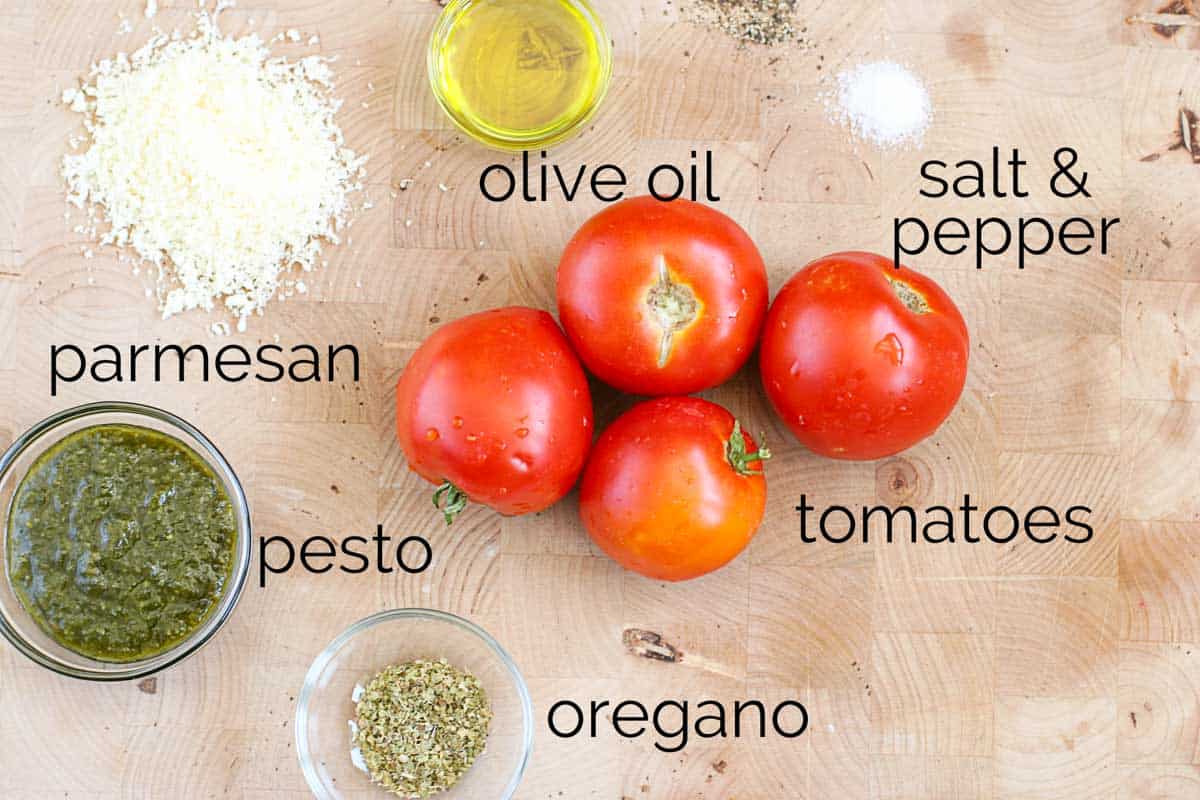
[396,307,593,523]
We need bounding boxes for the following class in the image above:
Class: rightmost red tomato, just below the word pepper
[758,253,970,459]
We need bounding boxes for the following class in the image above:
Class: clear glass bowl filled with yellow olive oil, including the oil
[428,0,612,150]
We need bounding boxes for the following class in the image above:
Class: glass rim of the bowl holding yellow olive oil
[425,0,613,152]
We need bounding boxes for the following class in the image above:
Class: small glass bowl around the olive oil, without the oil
[426,0,612,152]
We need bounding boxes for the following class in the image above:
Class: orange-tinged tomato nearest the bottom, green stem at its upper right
[580,397,770,581]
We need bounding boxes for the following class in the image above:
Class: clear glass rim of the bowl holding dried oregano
[293,608,534,800]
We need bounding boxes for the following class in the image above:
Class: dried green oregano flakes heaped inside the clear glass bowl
[352,658,492,798]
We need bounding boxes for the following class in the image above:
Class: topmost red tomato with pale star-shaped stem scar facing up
[558,196,768,395]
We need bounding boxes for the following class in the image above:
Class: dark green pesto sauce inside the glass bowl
[7,425,238,662]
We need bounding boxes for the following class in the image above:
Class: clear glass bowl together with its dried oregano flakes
[295,608,533,800]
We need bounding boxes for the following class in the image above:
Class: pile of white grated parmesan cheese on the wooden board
[62,5,366,330]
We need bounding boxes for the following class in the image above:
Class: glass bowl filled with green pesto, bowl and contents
[0,402,251,681]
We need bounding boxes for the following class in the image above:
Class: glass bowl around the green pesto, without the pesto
[0,403,251,681]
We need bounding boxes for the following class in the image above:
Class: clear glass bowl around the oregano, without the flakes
[295,608,533,800]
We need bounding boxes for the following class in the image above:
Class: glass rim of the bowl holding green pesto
[0,401,253,682]
